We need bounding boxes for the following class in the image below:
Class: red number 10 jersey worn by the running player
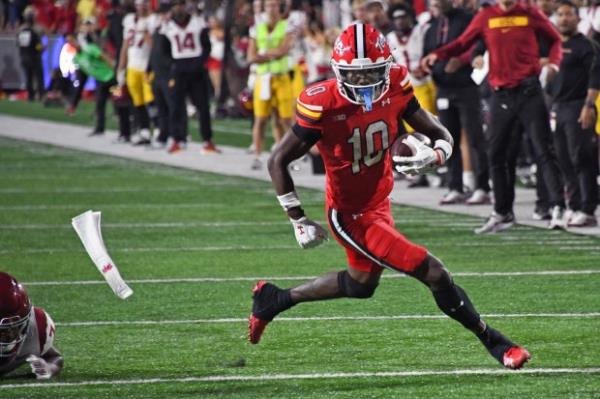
[293,66,418,213]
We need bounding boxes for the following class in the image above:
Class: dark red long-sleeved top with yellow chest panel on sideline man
[434,4,562,88]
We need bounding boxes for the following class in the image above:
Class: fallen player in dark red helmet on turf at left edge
[0,272,63,379]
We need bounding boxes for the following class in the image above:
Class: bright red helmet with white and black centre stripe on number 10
[331,24,393,111]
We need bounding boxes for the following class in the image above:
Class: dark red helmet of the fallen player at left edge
[0,272,33,358]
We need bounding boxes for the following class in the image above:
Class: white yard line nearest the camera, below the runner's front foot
[0,367,600,390]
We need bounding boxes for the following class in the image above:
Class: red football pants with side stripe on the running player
[327,199,427,273]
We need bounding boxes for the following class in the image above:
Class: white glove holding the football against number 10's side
[392,135,452,176]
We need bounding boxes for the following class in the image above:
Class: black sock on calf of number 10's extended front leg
[433,283,481,331]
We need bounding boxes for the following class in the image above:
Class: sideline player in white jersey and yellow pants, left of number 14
[117,0,154,145]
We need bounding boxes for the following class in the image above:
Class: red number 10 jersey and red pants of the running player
[293,66,427,272]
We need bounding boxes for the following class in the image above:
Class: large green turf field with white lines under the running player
[0,139,600,399]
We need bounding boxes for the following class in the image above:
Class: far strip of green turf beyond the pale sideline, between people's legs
[0,100,273,148]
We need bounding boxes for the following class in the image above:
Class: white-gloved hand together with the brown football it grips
[391,133,445,176]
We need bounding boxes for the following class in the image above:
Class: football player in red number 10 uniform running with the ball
[249,24,530,369]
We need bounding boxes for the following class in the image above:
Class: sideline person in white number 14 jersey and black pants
[162,0,220,154]
